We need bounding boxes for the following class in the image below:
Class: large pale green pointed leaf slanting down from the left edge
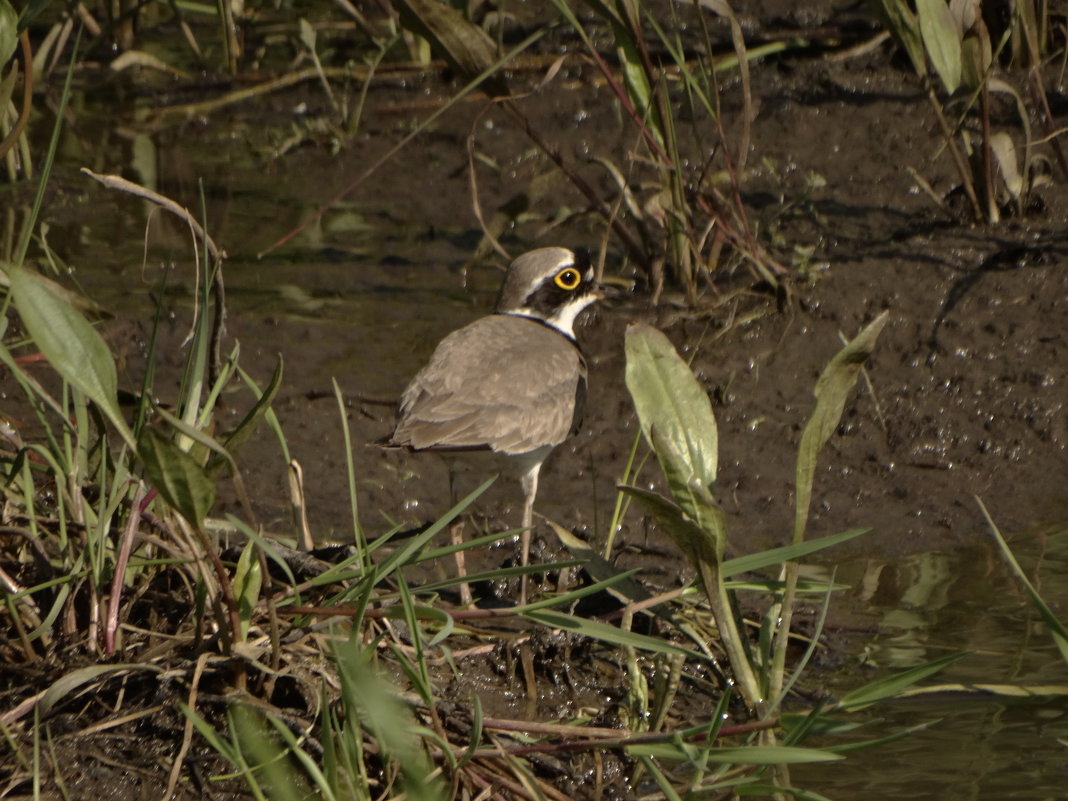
[4,265,134,446]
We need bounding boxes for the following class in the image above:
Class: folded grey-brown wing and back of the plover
[391,315,586,454]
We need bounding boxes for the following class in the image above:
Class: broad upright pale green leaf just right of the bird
[626,324,719,487]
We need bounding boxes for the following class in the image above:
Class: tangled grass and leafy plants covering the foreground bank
[0,211,969,799]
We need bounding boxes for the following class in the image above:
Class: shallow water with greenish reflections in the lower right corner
[794,520,1068,801]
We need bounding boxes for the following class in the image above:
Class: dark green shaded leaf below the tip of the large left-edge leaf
[137,427,215,529]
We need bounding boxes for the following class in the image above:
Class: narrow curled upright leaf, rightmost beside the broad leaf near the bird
[794,312,890,544]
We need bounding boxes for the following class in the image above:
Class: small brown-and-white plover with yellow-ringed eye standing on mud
[388,247,604,606]
